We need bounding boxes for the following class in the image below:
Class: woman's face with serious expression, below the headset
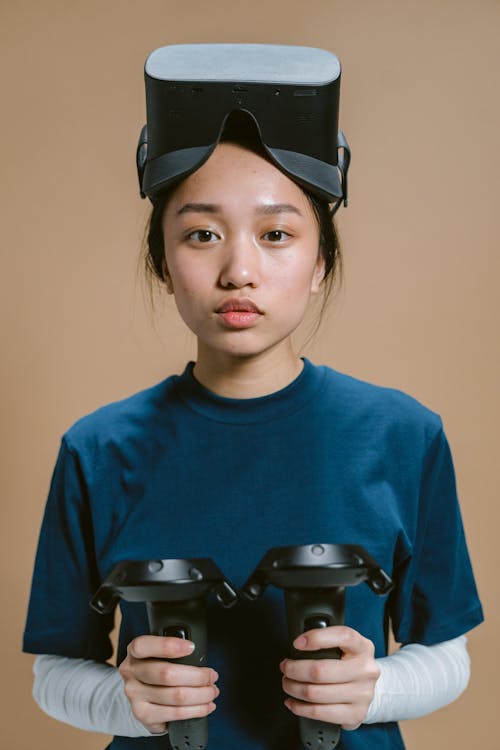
[163,143,324,370]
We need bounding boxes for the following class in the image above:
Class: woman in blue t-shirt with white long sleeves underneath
[25,44,482,750]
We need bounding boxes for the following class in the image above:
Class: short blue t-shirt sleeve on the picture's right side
[390,426,483,645]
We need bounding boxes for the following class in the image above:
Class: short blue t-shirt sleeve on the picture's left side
[23,438,113,660]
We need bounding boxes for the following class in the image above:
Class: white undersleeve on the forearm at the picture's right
[364,635,470,724]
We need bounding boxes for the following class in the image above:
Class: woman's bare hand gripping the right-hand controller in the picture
[280,625,380,729]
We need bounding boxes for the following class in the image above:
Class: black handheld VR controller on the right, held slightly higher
[242,544,393,750]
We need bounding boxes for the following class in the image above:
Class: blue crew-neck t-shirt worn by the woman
[24,360,482,750]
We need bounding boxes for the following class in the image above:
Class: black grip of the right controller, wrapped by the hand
[285,587,345,750]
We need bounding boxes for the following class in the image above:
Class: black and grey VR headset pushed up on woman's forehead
[137,44,350,212]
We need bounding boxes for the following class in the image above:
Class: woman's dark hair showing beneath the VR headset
[144,112,342,312]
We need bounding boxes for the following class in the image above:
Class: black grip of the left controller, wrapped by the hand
[146,598,208,750]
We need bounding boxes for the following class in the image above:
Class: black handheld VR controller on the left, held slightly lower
[90,558,237,750]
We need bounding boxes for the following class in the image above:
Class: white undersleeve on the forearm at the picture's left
[33,654,168,737]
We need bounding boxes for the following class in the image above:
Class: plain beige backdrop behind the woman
[0,0,500,750]
